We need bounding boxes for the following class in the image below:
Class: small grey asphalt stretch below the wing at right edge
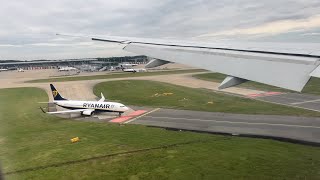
[256,93,320,112]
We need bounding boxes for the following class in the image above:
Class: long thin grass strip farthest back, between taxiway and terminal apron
[26,69,206,83]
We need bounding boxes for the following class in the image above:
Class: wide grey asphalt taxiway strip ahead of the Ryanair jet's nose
[129,109,320,144]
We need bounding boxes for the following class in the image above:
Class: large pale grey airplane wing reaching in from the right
[57,36,320,91]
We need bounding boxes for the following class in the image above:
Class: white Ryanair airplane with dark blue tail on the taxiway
[41,84,129,116]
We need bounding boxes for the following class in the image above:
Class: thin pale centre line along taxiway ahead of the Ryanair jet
[144,116,320,129]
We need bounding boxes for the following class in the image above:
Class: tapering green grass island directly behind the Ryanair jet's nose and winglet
[94,80,320,116]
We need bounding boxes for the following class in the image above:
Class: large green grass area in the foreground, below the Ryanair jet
[0,88,320,180]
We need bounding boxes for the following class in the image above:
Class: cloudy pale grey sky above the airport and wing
[0,0,320,60]
